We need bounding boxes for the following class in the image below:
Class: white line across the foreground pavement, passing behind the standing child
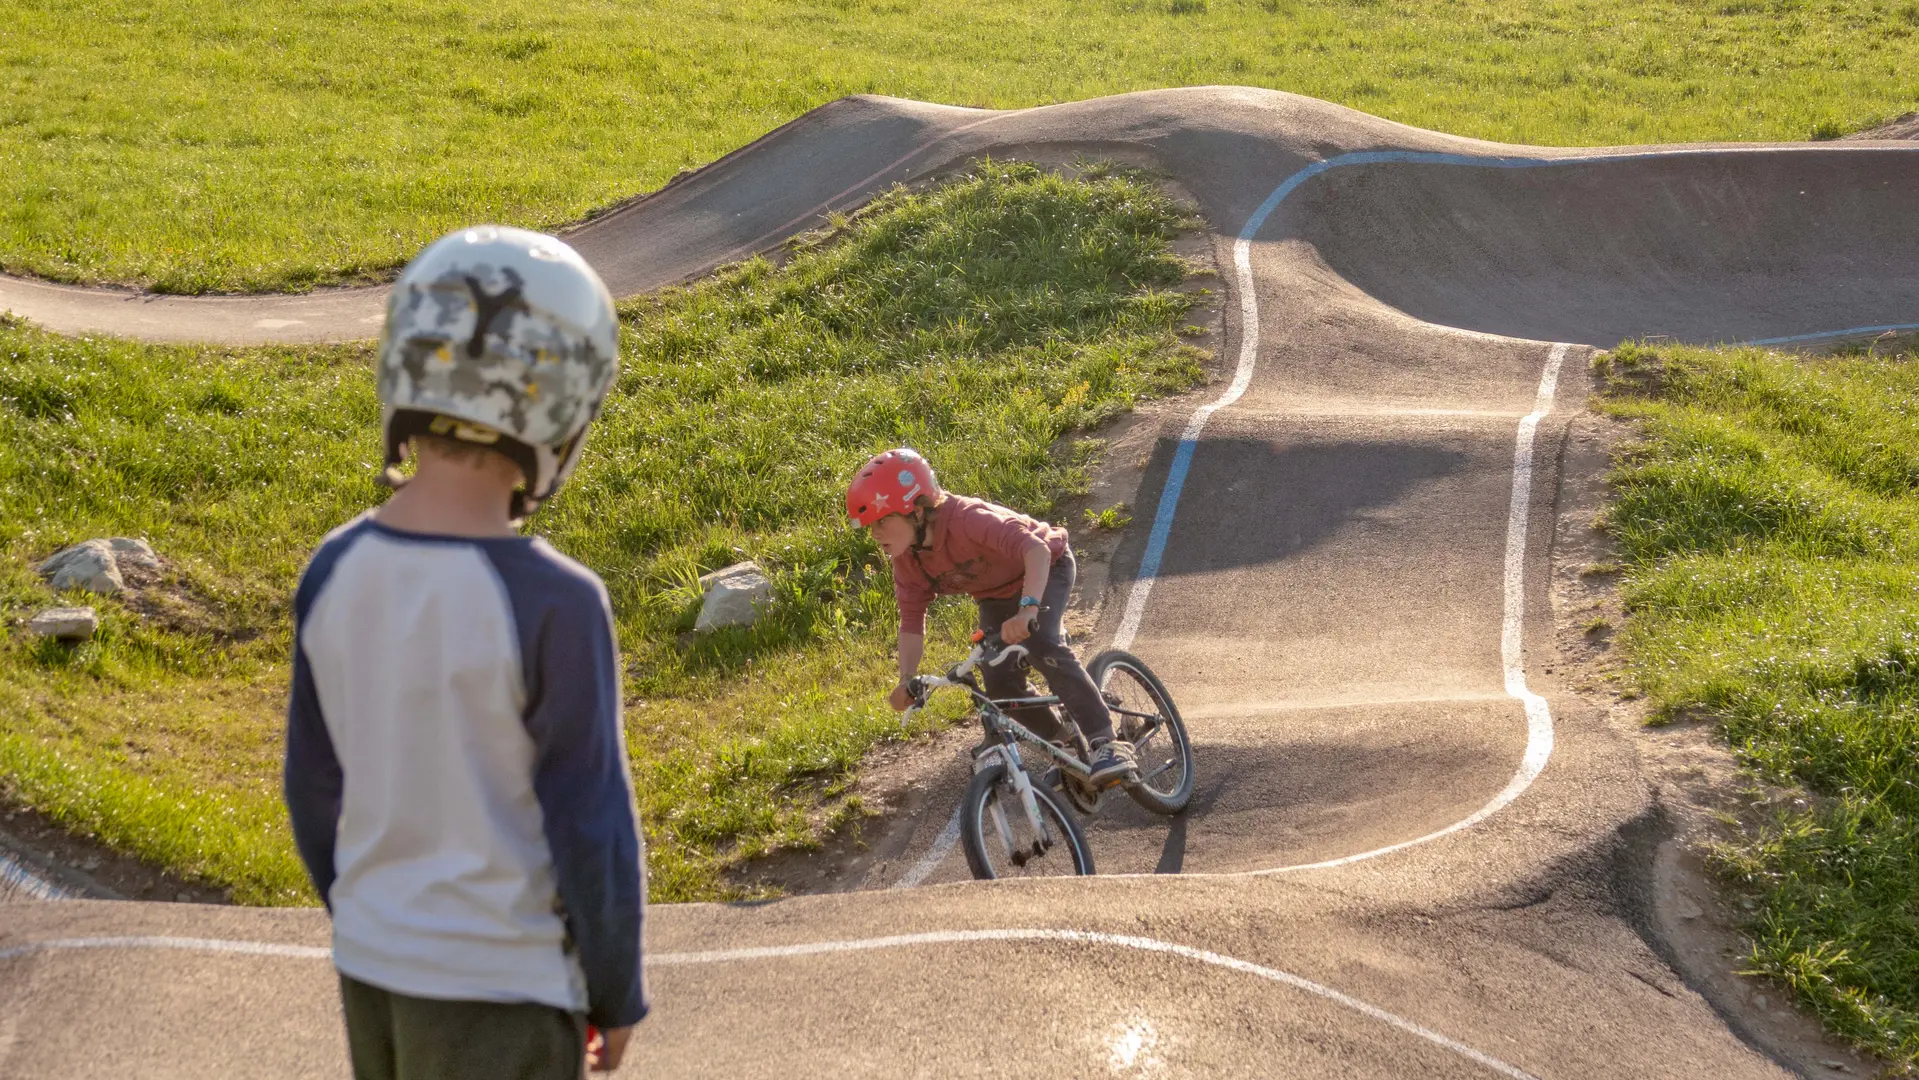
[0,928,1539,1080]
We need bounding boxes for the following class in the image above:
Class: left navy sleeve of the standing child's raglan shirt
[280,526,359,911]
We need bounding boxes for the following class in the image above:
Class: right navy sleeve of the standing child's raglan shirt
[491,545,649,1028]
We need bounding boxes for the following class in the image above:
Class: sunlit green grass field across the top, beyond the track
[11,0,1919,292]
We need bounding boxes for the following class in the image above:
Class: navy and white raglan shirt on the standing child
[286,516,647,1028]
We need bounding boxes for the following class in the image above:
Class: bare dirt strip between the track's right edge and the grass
[1552,400,1886,1076]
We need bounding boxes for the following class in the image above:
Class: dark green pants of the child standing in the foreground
[340,974,587,1080]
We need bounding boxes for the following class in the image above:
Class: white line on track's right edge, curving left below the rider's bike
[1253,343,1568,873]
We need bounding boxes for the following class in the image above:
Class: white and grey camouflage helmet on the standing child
[380,224,620,518]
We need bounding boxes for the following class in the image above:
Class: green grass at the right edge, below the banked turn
[1600,345,1919,1072]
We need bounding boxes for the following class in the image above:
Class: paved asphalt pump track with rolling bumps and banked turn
[0,88,1919,1080]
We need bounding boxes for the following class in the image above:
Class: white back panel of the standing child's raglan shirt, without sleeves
[301,529,585,1011]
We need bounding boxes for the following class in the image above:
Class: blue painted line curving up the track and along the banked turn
[1115,146,1919,648]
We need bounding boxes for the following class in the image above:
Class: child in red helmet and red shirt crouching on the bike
[846,447,1138,787]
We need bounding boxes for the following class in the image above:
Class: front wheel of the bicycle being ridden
[960,763,1092,880]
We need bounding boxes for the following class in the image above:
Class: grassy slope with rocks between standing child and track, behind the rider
[0,165,1201,904]
